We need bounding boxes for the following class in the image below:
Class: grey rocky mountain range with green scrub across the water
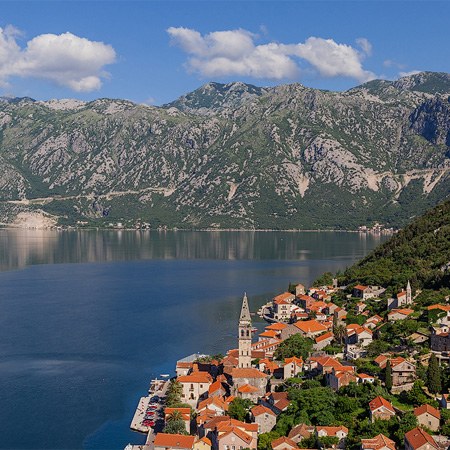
[0,73,450,229]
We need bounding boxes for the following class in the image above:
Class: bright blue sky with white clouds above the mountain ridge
[0,0,450,105]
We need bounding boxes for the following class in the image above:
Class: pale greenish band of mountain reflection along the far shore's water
[0,229,386,271]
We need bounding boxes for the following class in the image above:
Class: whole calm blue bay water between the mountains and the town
[0,230,385,449]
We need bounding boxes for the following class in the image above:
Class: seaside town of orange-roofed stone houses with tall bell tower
[126,279,450,450]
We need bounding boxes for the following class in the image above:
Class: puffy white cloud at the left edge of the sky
[0,27,116,92]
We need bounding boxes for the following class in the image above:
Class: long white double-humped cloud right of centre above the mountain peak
[167,27,375,81]
